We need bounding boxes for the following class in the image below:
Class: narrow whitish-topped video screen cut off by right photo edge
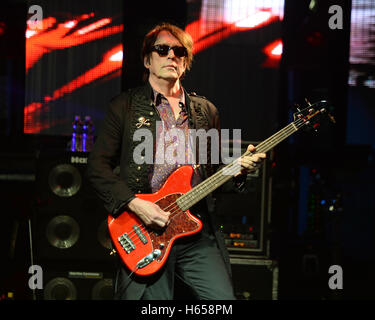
[346,0,375,148]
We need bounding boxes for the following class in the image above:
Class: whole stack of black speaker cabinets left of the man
[32,152,115,299]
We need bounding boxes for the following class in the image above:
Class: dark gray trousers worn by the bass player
[115,227,235,300]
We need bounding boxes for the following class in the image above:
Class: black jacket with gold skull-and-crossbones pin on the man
[87,83,229,215]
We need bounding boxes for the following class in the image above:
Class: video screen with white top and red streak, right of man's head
[183,0,284,141]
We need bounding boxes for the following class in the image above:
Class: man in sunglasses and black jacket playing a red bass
[87,23,266,300]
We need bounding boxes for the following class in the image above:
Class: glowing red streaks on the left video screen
[24,13,123,133]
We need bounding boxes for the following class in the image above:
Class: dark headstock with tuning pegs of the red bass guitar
[293,99,336,131]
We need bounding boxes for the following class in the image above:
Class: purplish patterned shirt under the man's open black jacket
[149,90,201,192]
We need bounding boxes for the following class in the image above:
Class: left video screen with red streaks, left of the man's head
[24,0,123,135]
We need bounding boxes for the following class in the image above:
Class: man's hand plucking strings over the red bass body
[128,198,170,228]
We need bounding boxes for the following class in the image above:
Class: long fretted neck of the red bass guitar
[177,122,300,211]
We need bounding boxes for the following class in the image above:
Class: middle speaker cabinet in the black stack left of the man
[33,208,112,262]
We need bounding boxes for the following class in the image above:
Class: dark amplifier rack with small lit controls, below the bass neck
[215,141,273,258]
